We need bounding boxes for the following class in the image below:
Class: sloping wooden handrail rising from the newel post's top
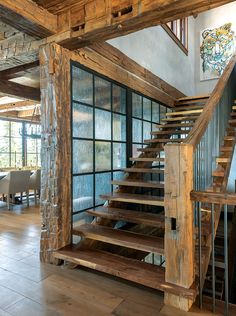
[184,54,236,149]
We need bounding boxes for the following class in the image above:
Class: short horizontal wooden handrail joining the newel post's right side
[190,191,236,205]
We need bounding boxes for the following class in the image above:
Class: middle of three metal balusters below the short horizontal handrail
[211,204,216,313]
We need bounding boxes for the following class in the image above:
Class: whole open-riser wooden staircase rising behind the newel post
[54,96,208,300]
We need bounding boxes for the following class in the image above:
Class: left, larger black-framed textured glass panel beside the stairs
[72,64,127,218]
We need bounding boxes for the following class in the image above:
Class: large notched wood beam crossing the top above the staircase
[54,0,232,50]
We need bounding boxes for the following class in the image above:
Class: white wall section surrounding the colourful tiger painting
[195,1,236,94]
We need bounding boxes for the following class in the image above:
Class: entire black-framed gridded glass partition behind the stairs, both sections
[71,62,171,221]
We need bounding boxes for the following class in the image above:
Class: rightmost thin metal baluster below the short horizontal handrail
[224,205,229,316]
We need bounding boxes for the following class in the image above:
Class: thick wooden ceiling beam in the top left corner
[0,0,58,38]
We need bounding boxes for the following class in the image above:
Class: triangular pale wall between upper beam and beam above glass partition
[109,18,195,95]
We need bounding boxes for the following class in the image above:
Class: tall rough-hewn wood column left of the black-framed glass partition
[40,43,71,263]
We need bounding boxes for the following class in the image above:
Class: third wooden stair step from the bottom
[86,207,165,229]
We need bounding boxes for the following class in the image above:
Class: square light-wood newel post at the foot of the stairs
[165,144,194,311]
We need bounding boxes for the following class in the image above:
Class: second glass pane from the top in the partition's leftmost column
[73,103,93,138]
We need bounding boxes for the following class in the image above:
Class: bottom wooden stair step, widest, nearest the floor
[54,246,197,300]
